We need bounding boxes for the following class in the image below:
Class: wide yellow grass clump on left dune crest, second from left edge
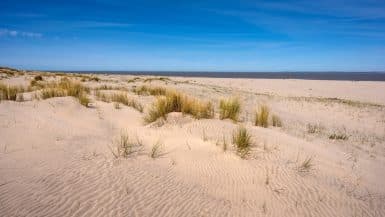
[36,78,90,107]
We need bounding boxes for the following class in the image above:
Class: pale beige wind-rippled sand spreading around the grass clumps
[0,70,385,217]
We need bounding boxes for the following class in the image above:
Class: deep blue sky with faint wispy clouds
[0,0,385,72]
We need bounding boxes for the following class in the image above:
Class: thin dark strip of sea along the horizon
[51,71,385,81]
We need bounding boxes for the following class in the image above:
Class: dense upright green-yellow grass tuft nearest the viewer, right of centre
[233,127,252,158]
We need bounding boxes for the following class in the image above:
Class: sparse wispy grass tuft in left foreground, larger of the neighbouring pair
[109,131,143,158]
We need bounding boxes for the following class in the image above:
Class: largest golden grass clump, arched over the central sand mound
[144,91,214,123]
